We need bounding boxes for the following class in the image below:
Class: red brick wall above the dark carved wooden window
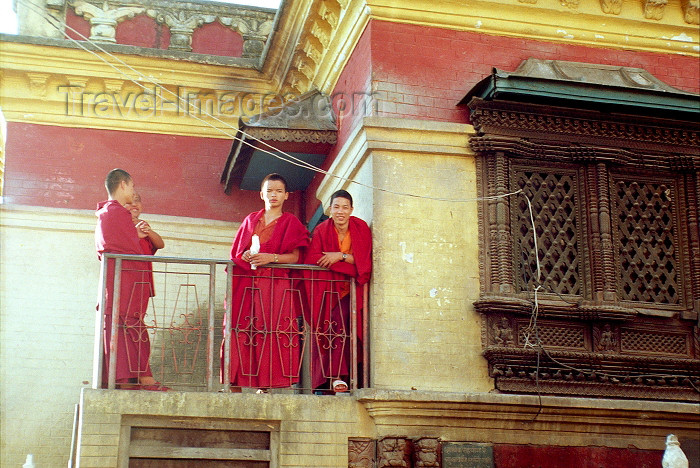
[371,20,700,122]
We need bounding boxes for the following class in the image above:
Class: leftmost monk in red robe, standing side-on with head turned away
[95,169,165,390]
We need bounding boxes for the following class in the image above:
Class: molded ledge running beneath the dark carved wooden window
[354,389,700,449]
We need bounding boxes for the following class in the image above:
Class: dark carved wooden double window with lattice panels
[470,99,700,401]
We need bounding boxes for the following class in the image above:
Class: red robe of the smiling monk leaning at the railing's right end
[305,216,372,388]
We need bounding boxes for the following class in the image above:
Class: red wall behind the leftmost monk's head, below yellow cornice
[4,122,299,221]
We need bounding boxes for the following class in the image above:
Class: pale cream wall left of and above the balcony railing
[0,205,236,467]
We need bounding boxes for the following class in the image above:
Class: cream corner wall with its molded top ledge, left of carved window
[316,117,493,392]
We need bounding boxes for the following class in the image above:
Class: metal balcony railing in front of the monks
[93,254,369,393]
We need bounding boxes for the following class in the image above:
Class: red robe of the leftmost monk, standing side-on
[95,200,153,386]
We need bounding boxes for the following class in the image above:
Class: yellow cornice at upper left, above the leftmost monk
[0,42,270,138]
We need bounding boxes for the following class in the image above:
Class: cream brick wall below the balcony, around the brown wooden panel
[80,389,374,468]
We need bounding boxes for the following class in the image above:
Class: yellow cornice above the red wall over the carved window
[365,0,700,51]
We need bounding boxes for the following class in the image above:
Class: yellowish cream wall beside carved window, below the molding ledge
[371,151,492,392]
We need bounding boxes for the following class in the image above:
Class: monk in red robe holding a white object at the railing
[221,174,309,391]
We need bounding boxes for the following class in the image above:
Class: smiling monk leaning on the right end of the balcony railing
[305,190,372,392]
